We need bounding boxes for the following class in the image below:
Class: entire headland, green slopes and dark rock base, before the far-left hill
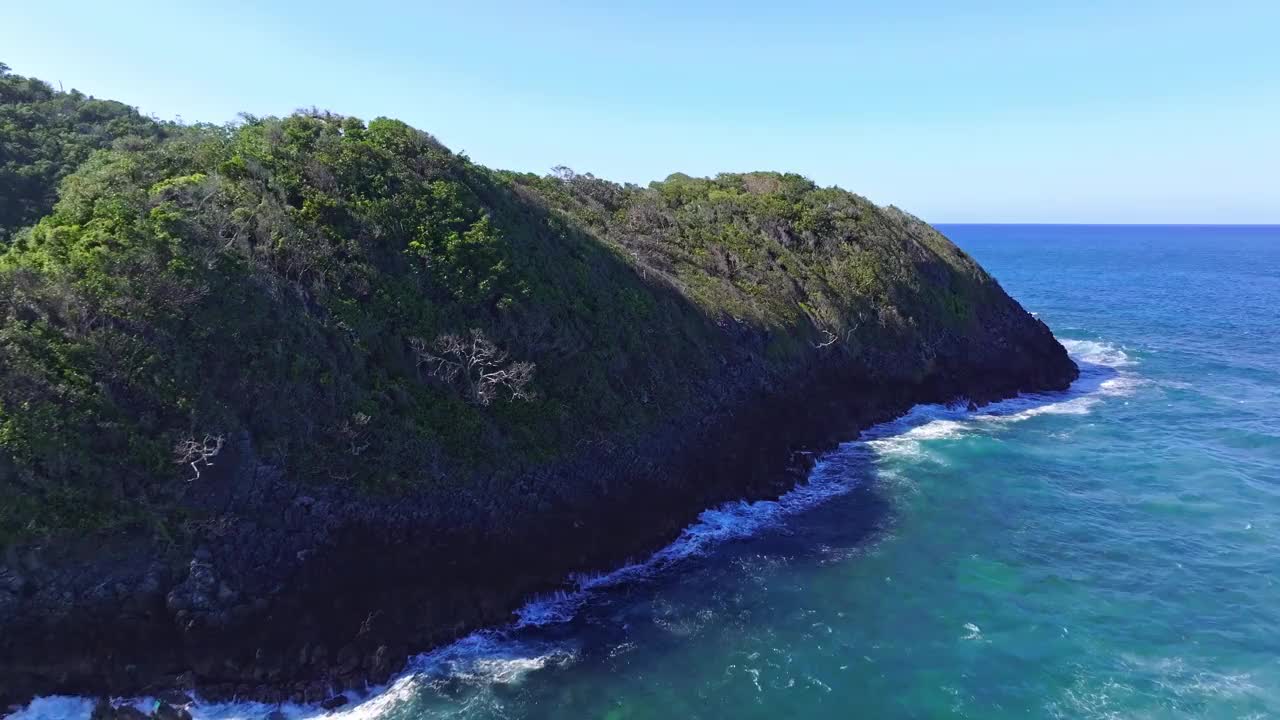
[0,77,1076,702]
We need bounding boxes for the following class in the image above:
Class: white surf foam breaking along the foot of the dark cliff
[12,340,1140,720]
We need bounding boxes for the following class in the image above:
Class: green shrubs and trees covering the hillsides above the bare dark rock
[0,64,997,543]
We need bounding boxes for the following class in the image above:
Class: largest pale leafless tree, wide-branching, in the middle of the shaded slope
[410,329,535,406]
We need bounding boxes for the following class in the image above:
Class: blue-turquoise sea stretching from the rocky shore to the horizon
[27,225,1280,720]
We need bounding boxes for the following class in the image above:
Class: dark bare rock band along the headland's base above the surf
[0,305,1078,707]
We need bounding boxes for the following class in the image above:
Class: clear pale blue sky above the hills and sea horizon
[0,0,1280,223]
